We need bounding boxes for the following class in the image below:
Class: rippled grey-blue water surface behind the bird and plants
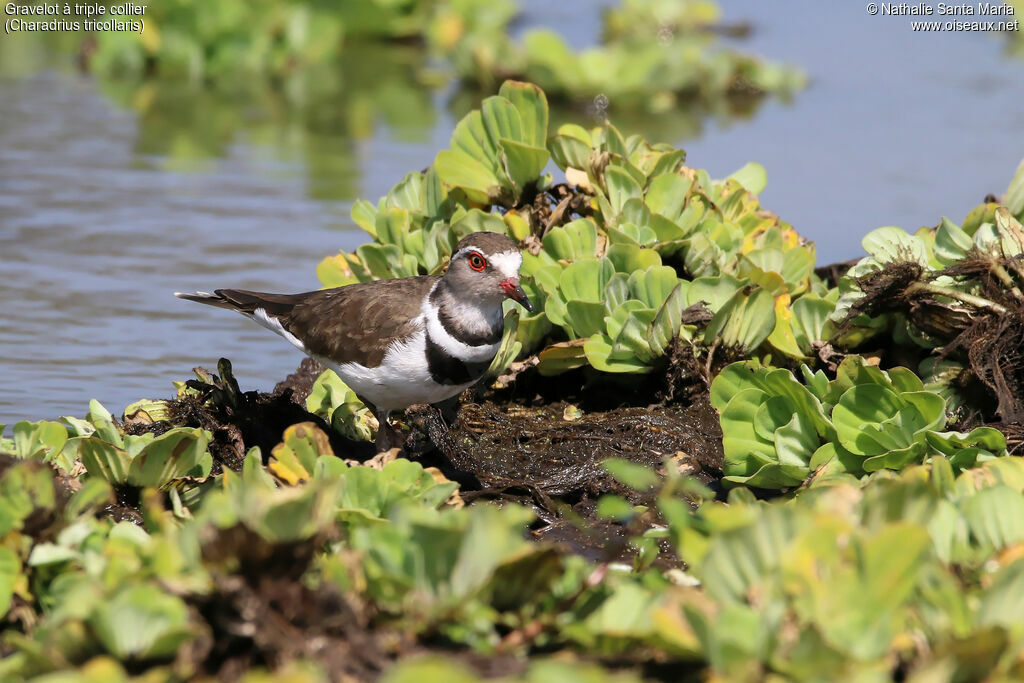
[0,0,1024,423]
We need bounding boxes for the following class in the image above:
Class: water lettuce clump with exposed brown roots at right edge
[829,170,1024,422]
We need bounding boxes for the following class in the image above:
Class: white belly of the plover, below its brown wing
[314,330,475,411]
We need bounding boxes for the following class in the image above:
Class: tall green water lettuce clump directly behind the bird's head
[317,81,834,387]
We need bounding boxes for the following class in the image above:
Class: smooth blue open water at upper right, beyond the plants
[685,0,1024,263]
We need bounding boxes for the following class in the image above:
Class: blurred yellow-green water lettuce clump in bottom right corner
[652,457,1024,680]
